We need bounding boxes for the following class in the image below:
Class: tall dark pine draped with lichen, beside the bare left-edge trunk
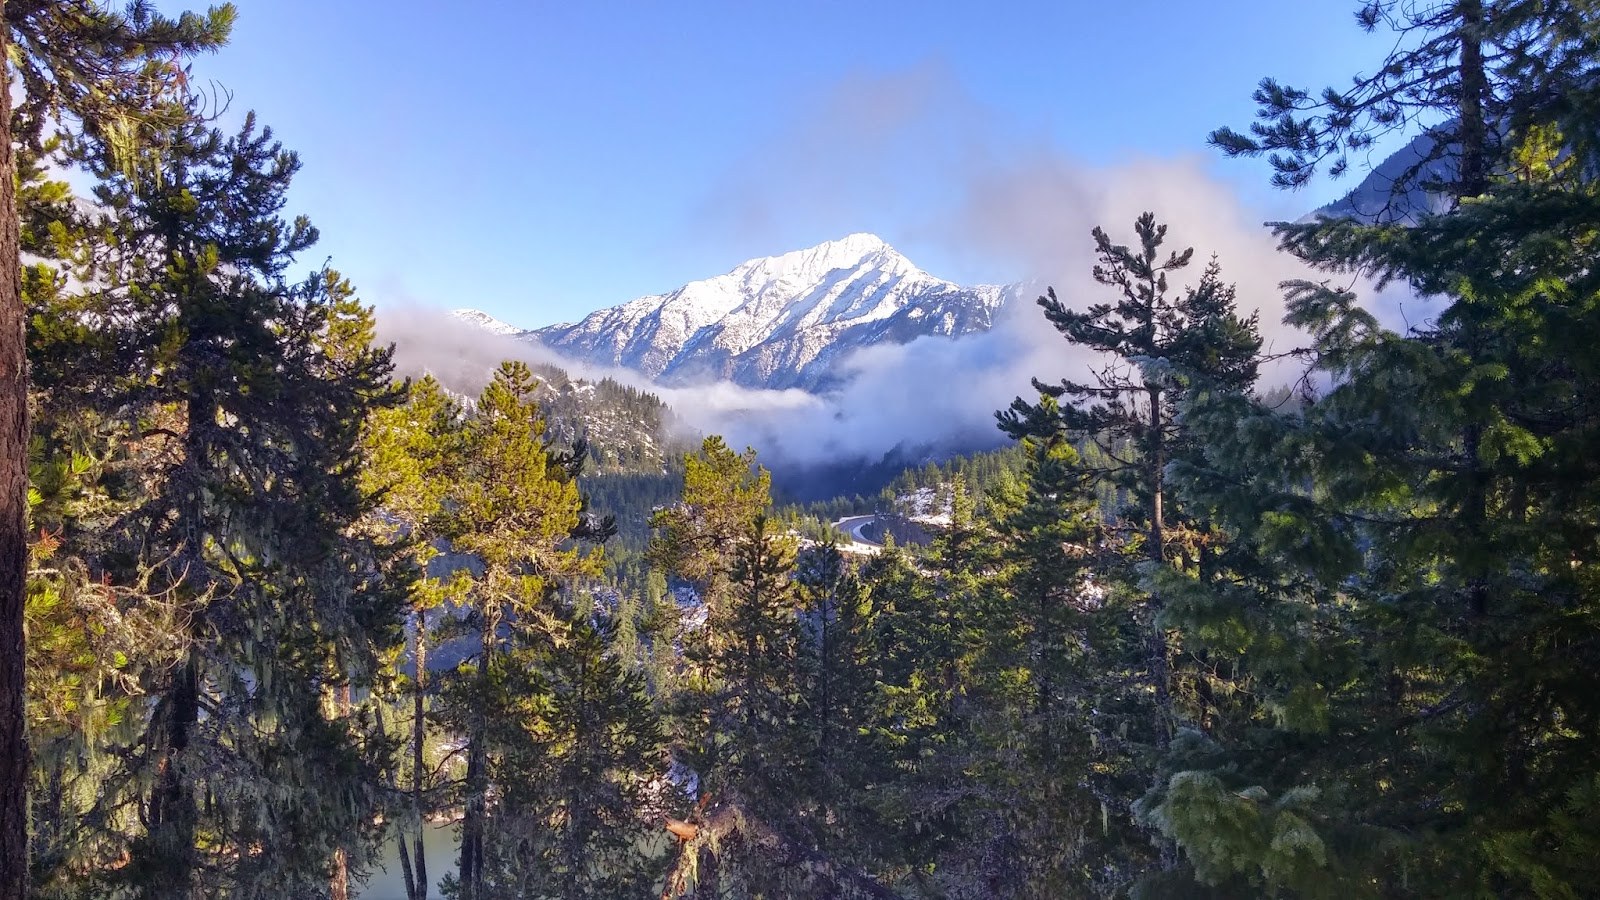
[16,101,406,895]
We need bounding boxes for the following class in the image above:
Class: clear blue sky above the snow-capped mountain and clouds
[162,0,1382,327]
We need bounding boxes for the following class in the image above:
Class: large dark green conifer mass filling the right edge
[1147,2,1597,897]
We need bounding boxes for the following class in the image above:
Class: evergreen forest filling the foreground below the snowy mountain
[9,0,1600,900]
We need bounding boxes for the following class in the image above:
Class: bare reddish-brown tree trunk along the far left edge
[0,0,29,898]
